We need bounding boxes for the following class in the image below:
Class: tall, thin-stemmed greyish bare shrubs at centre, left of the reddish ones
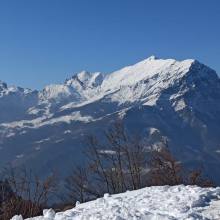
[66,122,150,202]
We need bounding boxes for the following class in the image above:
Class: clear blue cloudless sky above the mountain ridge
[0,0,220,89]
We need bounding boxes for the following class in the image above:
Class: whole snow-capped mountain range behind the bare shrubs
[0,56,220,182]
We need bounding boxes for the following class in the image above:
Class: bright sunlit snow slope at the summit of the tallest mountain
[102,56,195,90]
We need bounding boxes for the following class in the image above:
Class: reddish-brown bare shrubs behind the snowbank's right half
[149,144,214,187]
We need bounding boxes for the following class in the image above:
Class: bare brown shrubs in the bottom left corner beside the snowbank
[0,168,56,220]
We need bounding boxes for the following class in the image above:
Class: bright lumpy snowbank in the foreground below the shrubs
[12,185,220,220]
